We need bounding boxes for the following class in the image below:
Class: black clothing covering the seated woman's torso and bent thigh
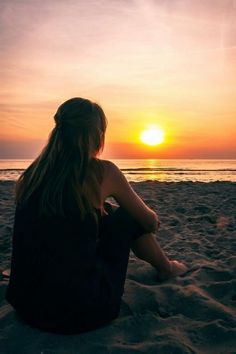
[6,201,145,333]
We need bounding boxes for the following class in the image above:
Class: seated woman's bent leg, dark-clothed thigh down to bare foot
[100,205,187,294]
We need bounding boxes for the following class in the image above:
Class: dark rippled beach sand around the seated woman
[0,182,236,354]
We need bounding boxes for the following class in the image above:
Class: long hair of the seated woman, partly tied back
[16,98,107,217]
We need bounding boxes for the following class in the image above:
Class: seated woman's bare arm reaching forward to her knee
[102,161,159,232]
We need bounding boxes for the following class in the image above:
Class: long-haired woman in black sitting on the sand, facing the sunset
[6,98,186,333]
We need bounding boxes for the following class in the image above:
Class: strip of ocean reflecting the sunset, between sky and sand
[0,159,236,182]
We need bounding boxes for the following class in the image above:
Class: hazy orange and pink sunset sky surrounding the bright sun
[0,0,236,159]
